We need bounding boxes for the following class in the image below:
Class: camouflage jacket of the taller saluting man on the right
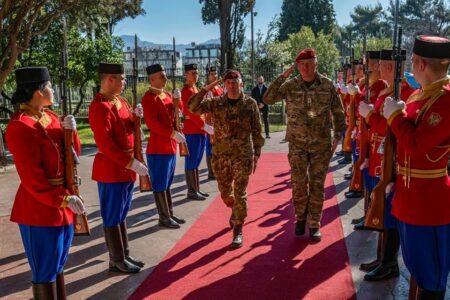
[264,73,345,148]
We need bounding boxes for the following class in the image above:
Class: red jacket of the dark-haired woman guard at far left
[5,104,80,226]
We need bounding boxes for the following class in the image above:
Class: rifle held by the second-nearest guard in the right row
[349,31,370,193]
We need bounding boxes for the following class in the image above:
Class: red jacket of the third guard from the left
[142,87,181,154]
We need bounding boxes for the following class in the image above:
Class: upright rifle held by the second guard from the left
[131,34,152,192]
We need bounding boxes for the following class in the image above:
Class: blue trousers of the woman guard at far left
[19,224,73,284]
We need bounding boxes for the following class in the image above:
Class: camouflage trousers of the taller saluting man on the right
[288,145,331,228]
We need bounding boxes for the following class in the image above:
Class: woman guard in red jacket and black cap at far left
[5,67,84,299]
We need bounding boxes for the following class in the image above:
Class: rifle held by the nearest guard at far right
[365,27,402,230]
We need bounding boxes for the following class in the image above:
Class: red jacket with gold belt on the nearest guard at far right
[388,78,450,226]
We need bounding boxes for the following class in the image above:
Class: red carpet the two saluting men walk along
[130,153,356,300]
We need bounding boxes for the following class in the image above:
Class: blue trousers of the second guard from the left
[97,182,134,227]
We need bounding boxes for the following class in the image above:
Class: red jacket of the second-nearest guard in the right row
[366,80,414,177]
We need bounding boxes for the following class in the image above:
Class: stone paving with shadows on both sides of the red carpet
[0,132,450,299]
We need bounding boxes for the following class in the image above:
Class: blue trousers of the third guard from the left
[147,154,177,192]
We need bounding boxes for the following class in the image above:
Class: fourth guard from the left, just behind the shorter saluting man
[181,64,214,200]
